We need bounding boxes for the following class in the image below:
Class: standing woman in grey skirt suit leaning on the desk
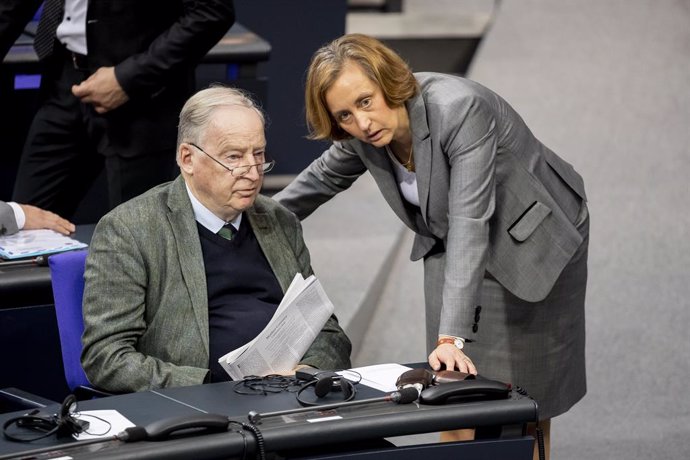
[274,34,589,454]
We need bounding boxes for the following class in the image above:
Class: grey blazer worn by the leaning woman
[274,73,586,338]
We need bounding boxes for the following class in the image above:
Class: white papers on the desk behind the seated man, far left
[0,230,87,259]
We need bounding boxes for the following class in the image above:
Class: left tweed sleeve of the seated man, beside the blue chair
[82,213,208,392]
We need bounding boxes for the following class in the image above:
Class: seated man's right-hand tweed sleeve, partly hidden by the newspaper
[272,205,352,370]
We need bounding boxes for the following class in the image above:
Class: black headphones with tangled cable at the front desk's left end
[2,394,89,442]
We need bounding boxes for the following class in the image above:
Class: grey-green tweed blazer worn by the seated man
[82,176,351,392]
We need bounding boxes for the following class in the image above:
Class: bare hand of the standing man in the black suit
[72,67,129,113]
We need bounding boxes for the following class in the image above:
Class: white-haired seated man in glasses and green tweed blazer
[82,87,351,392]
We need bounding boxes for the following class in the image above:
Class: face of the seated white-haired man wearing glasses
[178,105,266,222]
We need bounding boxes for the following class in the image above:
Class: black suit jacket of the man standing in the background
[0,0,235,156]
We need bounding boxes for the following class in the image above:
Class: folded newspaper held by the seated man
[218,273,334,380]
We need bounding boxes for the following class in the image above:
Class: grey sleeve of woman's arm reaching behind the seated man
[273,142,366,220]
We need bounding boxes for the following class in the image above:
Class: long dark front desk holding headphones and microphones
[0,382,537,460]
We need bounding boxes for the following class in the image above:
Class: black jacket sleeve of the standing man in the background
[115,0,235,97]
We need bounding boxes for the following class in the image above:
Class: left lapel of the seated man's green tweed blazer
[168,175,209,353]
